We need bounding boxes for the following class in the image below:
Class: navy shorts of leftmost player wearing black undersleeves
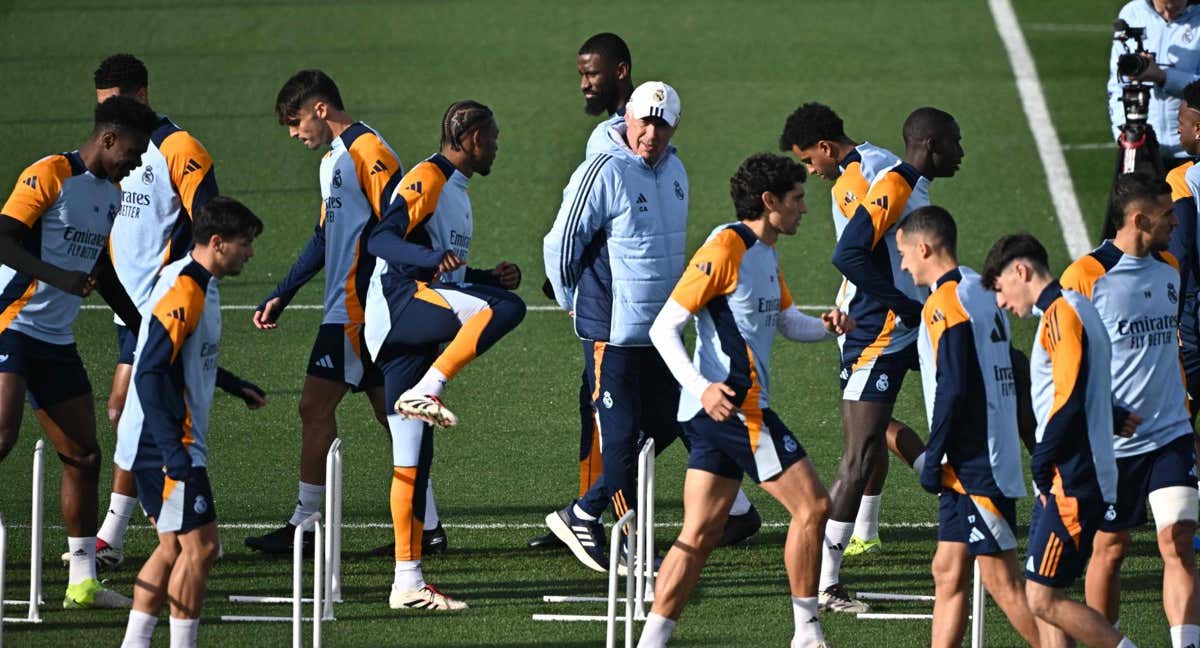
[0,329,91,409]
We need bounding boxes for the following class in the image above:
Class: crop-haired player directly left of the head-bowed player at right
[896,205,1039,647]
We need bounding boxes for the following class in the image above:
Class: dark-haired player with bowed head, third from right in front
[980,234,1138,648]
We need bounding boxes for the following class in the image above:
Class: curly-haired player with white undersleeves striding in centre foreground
[638,154,854,648]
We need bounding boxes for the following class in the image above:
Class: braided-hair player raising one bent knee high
[365,101,526,610]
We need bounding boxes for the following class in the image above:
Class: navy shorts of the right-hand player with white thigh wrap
[1100,434,1196,532]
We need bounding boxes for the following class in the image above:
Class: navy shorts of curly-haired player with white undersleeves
[683,408,806,484]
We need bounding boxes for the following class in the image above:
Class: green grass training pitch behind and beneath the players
[0,0,1168,648]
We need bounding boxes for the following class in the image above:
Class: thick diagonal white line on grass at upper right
[988,0,1092,259]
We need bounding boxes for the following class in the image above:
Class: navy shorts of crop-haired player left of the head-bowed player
[937,491,1016,556]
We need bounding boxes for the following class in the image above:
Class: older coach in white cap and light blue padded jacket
[542,82,689,571]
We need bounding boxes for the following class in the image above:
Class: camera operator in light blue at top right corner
[1108,0,1200,169]
